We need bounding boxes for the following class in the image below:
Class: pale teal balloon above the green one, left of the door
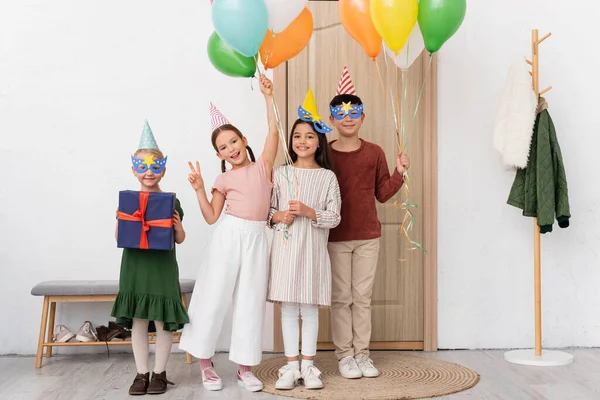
[211,0,269,57]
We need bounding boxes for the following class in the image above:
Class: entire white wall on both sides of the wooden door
[0,0,600,354]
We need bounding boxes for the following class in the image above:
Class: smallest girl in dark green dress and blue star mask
[111,121,189,395]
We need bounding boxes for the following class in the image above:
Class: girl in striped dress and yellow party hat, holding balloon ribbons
[267,91,342,390]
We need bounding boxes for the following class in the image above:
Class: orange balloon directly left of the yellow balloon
[338,0,381,61]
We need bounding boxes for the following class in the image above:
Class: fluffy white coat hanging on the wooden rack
[494,58,538,168]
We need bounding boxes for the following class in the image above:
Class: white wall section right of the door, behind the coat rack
[438,0,600,348]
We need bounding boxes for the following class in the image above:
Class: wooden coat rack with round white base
[504,29,573,367]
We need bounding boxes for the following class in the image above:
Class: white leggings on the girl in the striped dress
[281,303,319,357]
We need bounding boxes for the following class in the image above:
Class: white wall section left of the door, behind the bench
[0,0,272,354]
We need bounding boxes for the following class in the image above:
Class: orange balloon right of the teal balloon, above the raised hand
[259,7,313,69]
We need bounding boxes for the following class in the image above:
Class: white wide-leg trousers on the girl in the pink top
[179,215,269,366]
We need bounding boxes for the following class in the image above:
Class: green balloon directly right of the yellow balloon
[418,0,467,53]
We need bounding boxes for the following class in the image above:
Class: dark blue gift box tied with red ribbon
[117,190,175,250]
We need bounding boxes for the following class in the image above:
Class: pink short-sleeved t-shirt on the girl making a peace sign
[213,157,273,221]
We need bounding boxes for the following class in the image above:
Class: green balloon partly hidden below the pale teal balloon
[207,32,256,78]
